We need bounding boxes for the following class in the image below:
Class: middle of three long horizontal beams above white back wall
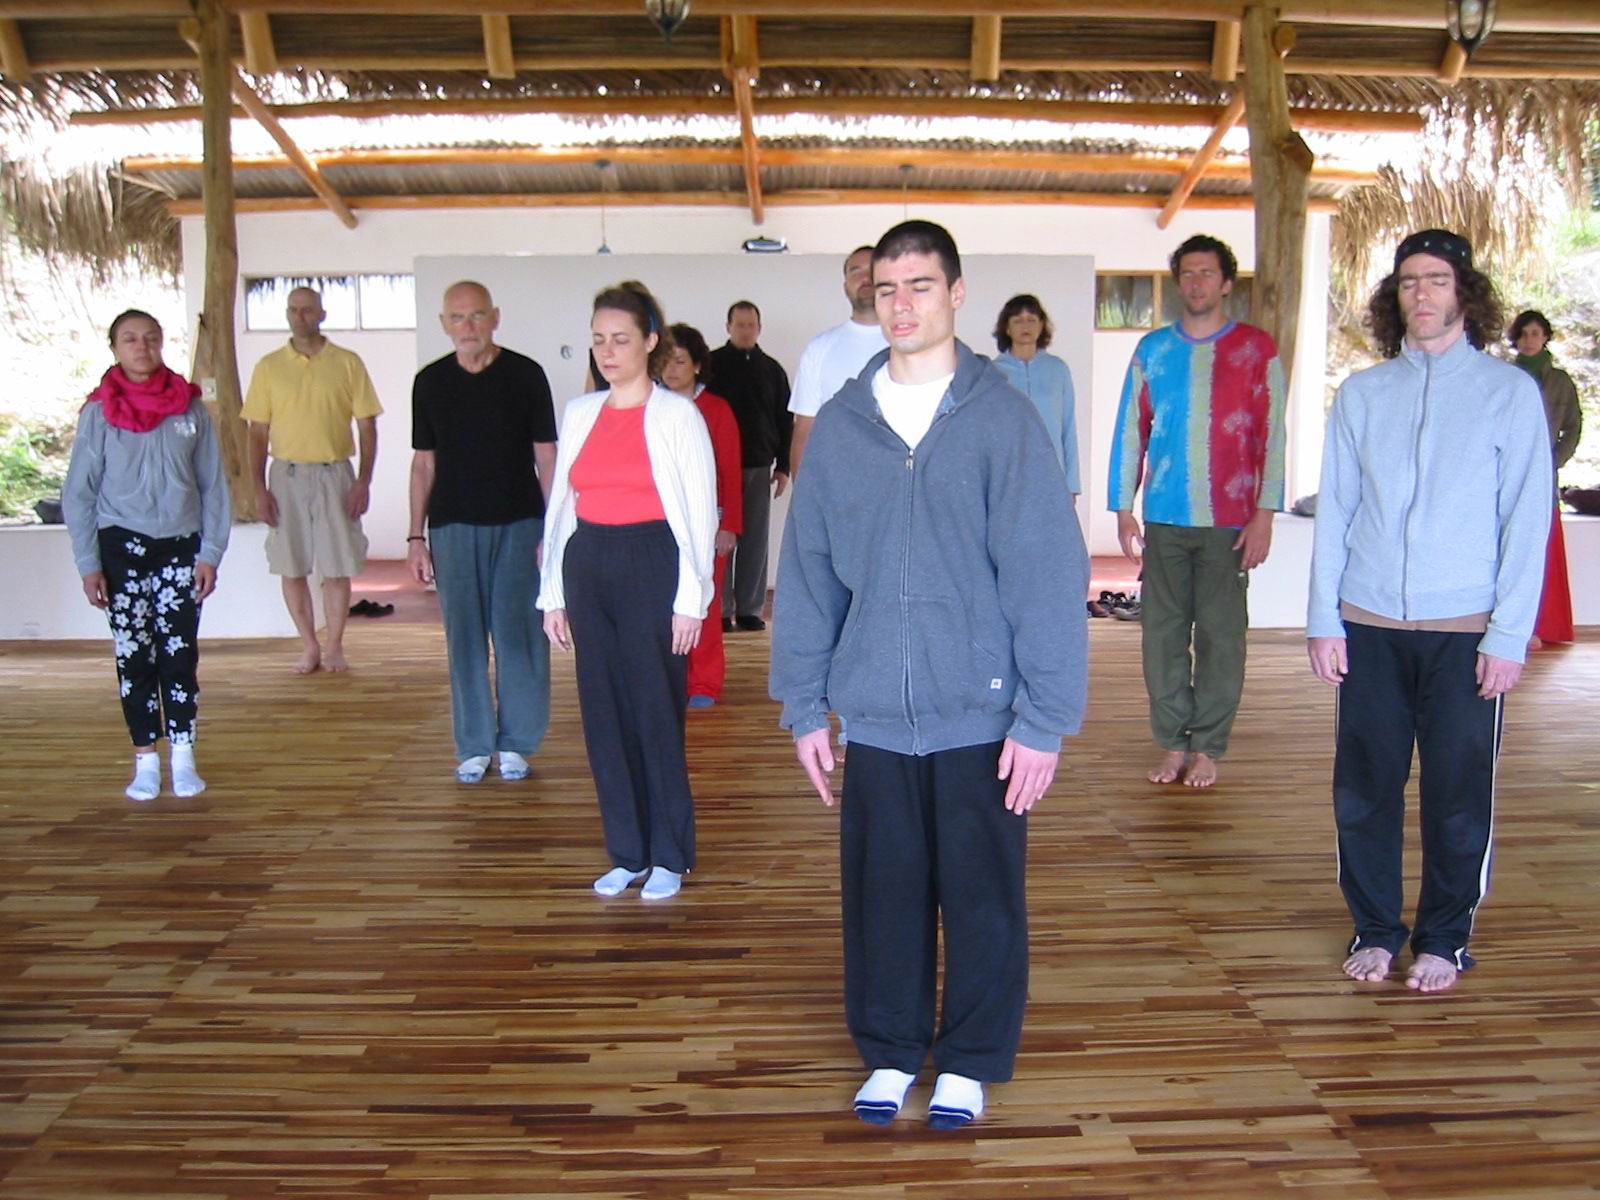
[122,144,1378,186]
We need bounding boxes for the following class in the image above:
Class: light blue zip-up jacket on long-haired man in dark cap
[1306,338,1554,662]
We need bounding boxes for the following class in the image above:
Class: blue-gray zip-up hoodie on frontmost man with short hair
[771,342,1088,754]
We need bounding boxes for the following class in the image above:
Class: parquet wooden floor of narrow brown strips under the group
[0,621,1600,1200]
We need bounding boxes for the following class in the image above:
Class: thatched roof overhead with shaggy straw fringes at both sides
[0,0,1600,286]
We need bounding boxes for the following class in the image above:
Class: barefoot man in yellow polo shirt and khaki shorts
[243,288,384,675]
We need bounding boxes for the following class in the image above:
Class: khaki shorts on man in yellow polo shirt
[267,459,366,579]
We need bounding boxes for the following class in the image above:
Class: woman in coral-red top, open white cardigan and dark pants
[539,282,717,901]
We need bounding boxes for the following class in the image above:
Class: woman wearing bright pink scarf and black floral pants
[61,309,232,800]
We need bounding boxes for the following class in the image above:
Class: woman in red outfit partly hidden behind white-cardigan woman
[661,325,744,709]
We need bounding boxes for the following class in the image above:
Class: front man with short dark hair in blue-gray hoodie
[771,221,1088,1128]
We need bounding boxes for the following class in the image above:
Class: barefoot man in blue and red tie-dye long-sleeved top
[1109,235,1285,787]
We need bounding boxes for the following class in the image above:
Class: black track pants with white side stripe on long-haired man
[1333,622,1502,970]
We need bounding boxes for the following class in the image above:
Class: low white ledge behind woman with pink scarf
[0,525,322,642]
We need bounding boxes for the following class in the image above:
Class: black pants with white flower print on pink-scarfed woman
[99,525,200,746]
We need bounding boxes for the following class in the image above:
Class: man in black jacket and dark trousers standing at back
[706,301,794,632]
